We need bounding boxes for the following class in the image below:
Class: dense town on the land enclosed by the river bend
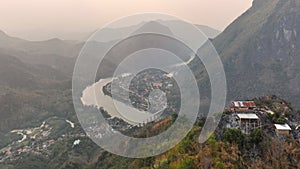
[103,69,176,112]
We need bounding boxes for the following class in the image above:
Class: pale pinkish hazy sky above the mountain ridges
[0,0,252,40]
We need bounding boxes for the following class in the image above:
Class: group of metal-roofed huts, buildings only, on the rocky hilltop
[227,101,292,136]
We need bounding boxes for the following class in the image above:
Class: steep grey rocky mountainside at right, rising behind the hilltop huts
[194,0,300,107]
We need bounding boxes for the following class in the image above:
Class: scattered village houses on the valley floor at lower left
[0,112,133,162]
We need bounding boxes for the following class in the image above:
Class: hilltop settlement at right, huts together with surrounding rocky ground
[225,101,300,141]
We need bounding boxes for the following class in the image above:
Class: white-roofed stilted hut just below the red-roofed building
[236,113,261,134]
